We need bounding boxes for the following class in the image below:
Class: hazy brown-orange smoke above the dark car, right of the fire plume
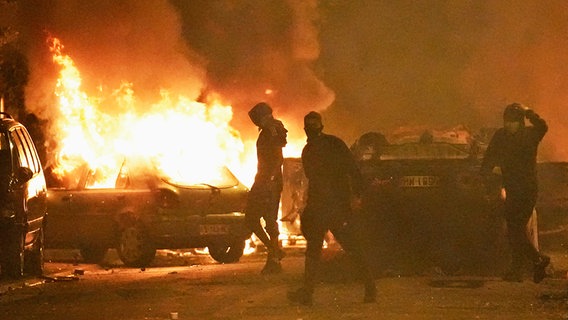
[320,0,568,160]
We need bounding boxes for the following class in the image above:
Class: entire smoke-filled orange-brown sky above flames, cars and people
[0,0,568,160]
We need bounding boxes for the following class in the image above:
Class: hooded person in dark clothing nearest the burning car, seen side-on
[245,102,288,274]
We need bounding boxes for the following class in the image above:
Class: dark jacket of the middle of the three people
[302,134,362,215]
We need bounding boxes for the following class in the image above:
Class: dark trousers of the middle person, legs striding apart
[301,214,375,292]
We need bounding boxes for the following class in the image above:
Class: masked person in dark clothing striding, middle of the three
[288,111,376,305]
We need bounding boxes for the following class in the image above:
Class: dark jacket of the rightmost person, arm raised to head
[481,110,548,195]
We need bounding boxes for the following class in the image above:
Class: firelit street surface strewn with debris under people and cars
[0,247,568,320]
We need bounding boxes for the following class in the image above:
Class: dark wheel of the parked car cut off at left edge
[2,228,25,279]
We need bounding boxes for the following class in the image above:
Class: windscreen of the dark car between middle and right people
[380,142,470,160]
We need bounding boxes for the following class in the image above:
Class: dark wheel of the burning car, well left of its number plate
[118,225,156,268]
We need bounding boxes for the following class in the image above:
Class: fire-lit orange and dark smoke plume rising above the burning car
[10,0,334,142]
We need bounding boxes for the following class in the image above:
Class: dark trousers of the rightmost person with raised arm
[505,194,540,272]
